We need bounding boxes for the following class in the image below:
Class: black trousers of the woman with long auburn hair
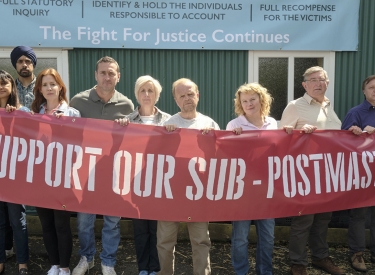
[36,207,73,268]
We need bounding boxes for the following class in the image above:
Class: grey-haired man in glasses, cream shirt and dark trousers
[280,66,345,275]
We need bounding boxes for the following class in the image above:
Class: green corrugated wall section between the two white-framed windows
[69,49,248,128]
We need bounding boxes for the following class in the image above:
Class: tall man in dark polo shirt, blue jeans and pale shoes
[70,56,134,275]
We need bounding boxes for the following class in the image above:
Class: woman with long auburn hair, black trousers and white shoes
[31,68,81,275]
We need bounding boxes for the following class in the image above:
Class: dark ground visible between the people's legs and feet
[5,236,375,275]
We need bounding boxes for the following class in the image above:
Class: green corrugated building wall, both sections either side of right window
[69,0,375,128]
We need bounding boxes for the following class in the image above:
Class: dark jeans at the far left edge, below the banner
[0,202,29,264]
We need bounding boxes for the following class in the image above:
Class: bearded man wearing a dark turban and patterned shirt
[10,46,37,109]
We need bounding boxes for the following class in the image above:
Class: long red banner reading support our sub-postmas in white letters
[0,111,375,221]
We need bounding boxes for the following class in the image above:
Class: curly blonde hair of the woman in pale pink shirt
[234,83,273,117]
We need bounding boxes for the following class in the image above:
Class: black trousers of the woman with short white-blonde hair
[133,219,160,272]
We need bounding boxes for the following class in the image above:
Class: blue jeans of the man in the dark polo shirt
[77,213,121,267]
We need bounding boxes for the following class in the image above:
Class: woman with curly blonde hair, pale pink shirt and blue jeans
[227,83,277,275]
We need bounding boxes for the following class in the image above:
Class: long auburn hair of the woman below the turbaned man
[31,68,68,113]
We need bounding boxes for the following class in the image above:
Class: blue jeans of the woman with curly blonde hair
[231,219,275,275]
